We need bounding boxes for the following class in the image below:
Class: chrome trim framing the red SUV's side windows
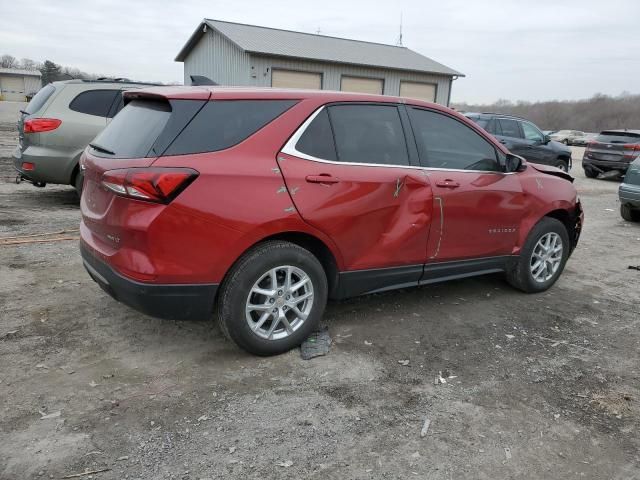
[279,102,526,175]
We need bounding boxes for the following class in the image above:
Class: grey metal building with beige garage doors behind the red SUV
[176,19,464,105]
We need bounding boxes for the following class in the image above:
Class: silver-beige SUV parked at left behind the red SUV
[13,79,158,195]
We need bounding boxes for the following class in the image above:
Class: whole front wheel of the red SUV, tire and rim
[507,217,570,293]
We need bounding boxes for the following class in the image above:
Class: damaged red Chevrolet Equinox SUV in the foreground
[81,87,582,355]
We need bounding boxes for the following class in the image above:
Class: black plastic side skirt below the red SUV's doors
[331,255,518,300]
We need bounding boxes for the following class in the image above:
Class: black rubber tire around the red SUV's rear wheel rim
[216,241,328,356]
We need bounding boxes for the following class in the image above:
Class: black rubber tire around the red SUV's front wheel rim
[506,217,570,293]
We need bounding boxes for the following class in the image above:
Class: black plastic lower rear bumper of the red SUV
[80,242,218,320]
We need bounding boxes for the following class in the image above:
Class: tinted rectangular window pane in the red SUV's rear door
[328,105,409,165]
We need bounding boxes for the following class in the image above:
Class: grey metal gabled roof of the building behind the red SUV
[176,18,464,77]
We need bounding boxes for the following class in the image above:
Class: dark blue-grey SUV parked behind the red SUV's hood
[464,113,571,172]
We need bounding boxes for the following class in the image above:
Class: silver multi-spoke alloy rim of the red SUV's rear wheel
[245,265,314,340]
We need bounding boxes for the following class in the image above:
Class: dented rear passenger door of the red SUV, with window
[278,103,433,278]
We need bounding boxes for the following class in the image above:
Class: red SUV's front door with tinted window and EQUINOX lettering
[408,107,525,262]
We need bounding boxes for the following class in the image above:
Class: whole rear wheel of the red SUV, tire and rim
[217,241,328,355]
